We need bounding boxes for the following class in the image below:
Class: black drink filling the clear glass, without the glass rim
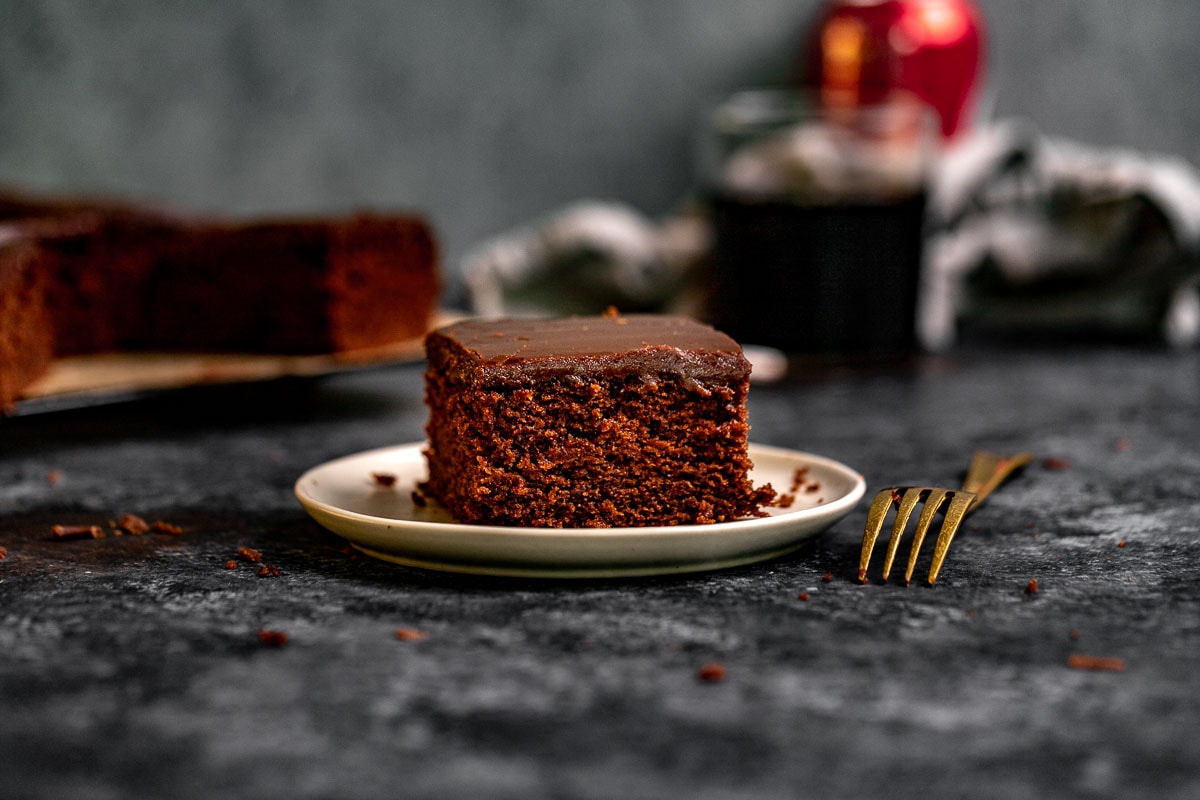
[710,192,925,356]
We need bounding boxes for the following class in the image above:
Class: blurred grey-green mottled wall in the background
[0,0,1200,303]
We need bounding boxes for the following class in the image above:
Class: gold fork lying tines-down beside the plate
[858,450,1033,585]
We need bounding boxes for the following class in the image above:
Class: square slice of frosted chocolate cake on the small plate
[425,315,774,528]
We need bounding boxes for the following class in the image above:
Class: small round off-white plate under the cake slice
[295,444,866,578]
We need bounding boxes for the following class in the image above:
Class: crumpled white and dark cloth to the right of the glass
[920,122,1200,349]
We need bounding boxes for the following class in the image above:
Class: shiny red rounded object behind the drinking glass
[803,0,985,139]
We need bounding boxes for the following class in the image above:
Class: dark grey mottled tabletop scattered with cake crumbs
[0,345,1200,800]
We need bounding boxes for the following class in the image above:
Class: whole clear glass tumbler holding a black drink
[707,91,936,357]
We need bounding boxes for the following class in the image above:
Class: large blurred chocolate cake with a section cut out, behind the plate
[0,191,442,408]
